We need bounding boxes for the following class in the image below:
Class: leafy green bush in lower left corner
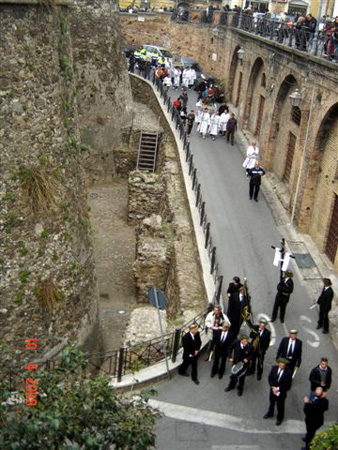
[0,346,160,450]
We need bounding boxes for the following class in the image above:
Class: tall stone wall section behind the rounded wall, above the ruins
[69,0,132,183]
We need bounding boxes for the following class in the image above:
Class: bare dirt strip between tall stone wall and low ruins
[88,178,136,351]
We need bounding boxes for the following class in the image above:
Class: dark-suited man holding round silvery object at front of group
[224,334,252,397]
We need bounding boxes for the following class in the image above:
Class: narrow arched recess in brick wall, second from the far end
[243,57,264,130]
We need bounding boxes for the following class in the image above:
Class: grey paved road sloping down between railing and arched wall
[156,86,338,450]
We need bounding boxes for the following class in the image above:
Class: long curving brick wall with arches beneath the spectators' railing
[121,15,338,268]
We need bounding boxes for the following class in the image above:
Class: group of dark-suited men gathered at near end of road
[179,271,334,450]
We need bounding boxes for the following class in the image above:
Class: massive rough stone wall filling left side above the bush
[0,0,131,364]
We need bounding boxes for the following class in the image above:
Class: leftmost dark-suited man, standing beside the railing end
[178,324,202,384]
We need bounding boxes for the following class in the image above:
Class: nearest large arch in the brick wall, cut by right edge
[299,102,338,266]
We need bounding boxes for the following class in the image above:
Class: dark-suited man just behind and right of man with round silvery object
[249,319,271,380]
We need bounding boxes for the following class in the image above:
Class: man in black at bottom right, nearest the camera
[302,387,329,450]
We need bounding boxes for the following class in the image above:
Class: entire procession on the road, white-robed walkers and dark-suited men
[127,51,334,450]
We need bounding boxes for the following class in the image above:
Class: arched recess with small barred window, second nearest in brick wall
[264,74,299,172]
